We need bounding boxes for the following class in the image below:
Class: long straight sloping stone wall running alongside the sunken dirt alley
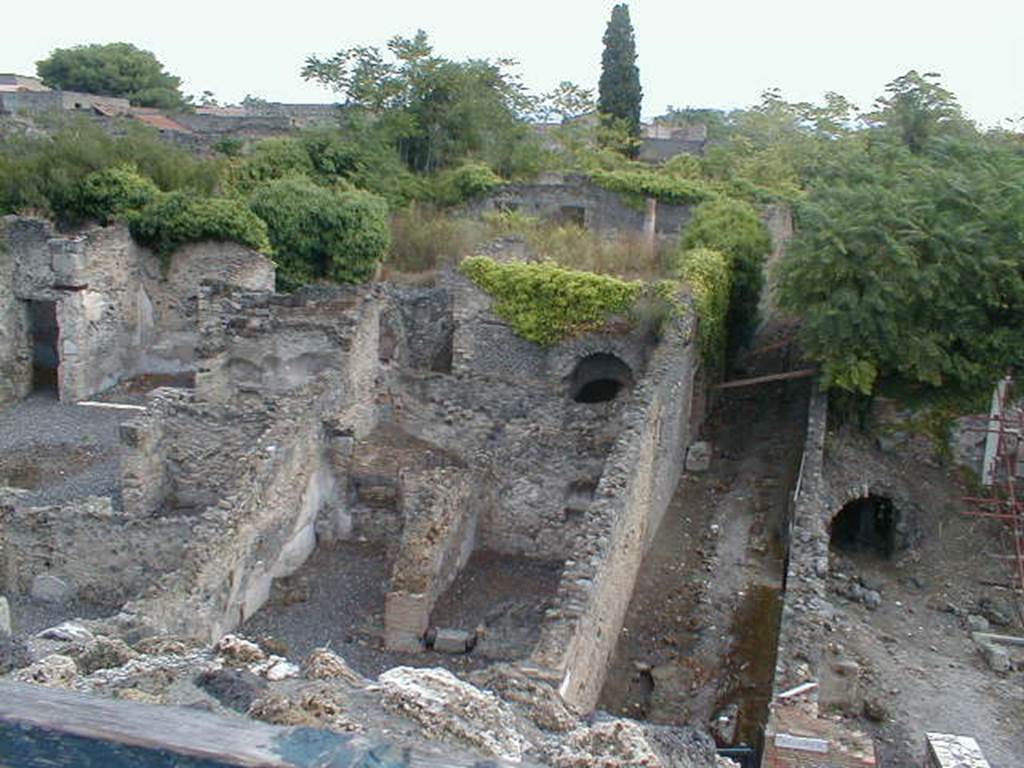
[524,316,700,711]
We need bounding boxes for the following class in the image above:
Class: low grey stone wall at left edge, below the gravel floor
[0,493,189,605]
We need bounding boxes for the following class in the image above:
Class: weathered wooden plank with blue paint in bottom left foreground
[0,681,522,768]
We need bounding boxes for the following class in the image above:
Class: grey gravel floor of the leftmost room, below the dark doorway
[0,393,129,505]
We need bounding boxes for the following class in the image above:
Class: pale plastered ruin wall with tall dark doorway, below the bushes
[0,216,274,404]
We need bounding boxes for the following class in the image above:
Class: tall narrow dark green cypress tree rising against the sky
[597,3,643,135]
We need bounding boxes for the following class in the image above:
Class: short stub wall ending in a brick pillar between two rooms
[384,467,481,652]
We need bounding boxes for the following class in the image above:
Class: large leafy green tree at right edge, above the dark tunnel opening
[779,137,1024,397]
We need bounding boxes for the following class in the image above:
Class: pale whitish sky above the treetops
[8,0,1024,125]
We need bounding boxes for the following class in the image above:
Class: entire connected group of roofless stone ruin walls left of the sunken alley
[0,219,700,765]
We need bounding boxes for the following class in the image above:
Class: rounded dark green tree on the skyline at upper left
[36,43,186,110]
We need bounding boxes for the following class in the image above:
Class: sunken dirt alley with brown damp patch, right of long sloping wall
[600,342,809,757]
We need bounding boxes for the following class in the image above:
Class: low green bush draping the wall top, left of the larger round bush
[130,191,270,263]
